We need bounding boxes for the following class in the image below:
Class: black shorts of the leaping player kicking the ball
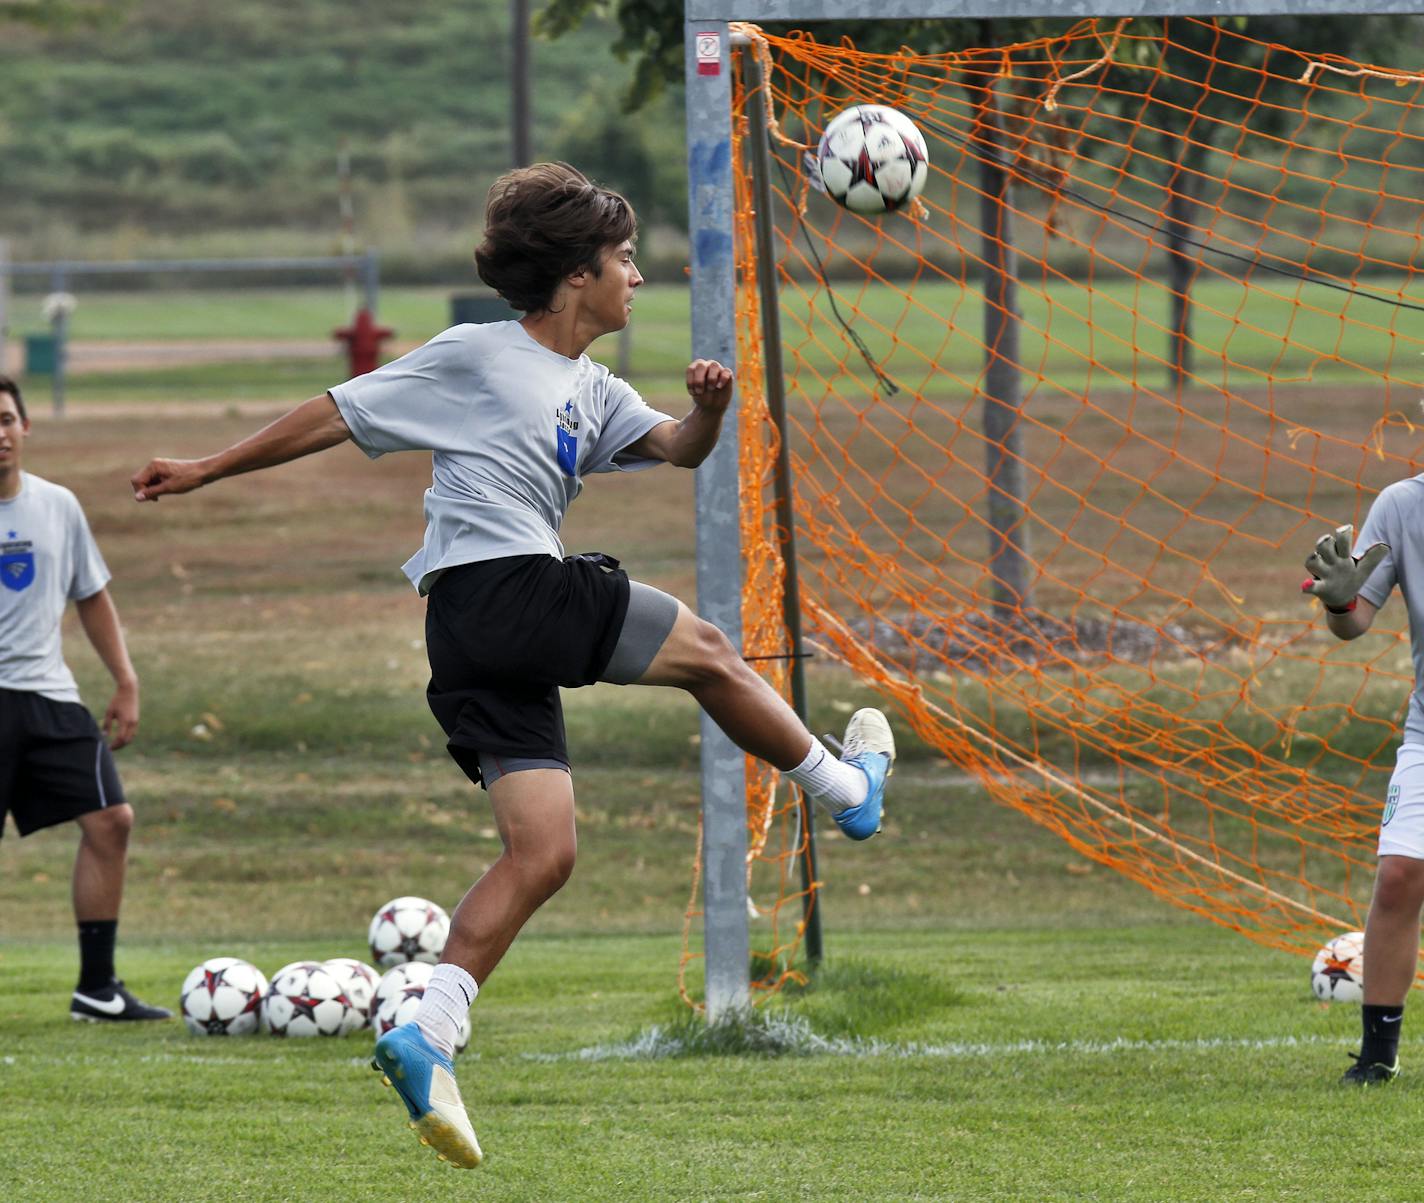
[426,555,628,784]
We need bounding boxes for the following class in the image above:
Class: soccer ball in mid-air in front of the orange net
[816,104,930,214]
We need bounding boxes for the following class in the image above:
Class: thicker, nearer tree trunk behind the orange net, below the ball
[974,78,1032,622]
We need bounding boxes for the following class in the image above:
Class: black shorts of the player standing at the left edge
[0,689,124,836]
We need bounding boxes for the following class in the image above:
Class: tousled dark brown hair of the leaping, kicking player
[474,162,638,313]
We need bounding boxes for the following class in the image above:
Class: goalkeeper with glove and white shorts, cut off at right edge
[1302,506,1424,1086]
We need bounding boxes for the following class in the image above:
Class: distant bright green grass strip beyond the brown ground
[10,272,1420,403]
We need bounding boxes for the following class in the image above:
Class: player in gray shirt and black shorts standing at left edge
[0,376,171,1024]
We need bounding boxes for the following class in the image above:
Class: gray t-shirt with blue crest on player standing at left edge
[0,473,108,702]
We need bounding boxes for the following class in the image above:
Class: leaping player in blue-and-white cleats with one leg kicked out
[132,164,894,1167]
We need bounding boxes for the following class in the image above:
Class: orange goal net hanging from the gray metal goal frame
[684,19,1424,989]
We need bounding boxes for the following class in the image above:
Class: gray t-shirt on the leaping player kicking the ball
[330,322,674,594]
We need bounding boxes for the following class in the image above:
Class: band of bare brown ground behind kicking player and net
[27,375,1424,619]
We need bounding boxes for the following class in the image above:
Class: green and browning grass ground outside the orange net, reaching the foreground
[0,409,1424,1203]
